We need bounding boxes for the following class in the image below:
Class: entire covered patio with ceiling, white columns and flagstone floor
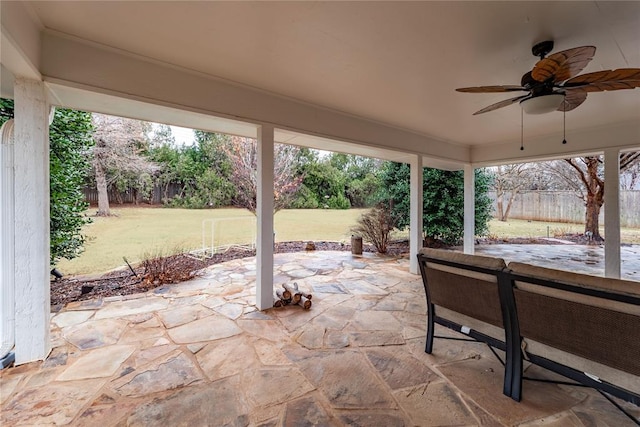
[0,1,640,426]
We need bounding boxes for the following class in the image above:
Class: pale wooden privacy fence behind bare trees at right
[489,190,640,227]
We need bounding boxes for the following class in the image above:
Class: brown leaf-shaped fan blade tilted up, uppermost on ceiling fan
[531,46,596,82]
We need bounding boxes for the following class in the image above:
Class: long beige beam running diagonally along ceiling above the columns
[41,31,470,163]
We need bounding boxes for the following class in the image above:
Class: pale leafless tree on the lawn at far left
[92,114,158,216]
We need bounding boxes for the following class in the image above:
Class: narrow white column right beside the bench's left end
[409,155,424,274]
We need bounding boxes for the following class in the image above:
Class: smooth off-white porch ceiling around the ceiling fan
[3,1,640,161]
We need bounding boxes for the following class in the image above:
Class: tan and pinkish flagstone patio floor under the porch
[0,252,640,427]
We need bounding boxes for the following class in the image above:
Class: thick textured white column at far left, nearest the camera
[14,78,51,365]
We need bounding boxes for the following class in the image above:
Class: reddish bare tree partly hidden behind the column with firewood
[226,136,302,215]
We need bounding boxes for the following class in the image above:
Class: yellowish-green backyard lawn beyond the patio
[56,207,640,275]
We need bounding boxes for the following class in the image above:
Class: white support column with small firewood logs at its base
[256,126,274,310]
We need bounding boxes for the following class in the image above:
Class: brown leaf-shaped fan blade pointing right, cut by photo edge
[562,68,640,92]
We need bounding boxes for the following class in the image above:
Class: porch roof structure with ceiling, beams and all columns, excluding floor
[5,1,640,364]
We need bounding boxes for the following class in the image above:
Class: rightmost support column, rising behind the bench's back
[604,149,620,279]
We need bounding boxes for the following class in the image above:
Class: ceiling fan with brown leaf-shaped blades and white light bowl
[456,41,640,115]
